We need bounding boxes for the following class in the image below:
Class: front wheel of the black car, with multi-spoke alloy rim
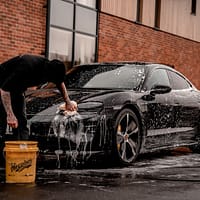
[114,108,141,165]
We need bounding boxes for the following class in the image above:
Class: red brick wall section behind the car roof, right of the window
[98,13,200,89]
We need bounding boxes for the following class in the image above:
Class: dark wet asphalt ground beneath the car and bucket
[0,149,200,200]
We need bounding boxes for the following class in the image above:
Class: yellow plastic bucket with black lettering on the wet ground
[4,141,38,183]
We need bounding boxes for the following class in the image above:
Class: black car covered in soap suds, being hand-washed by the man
[27,62,200,167]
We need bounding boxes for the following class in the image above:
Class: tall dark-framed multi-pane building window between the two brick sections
[47,0,98,69]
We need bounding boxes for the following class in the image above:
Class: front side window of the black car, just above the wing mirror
[145,69,170,90]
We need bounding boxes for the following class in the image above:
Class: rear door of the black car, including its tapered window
[168,71,200,144]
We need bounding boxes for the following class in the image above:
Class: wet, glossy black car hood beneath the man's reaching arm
[26,89,130,121]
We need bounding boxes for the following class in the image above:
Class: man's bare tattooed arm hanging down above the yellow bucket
[0,89,18,128]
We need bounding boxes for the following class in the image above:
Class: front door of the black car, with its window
[144,68,175,148]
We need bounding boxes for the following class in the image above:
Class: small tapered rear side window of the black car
[168,71,191,90]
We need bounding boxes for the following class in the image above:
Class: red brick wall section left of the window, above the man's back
[0,0,47,63]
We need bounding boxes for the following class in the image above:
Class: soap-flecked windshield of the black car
[65,64,145,89]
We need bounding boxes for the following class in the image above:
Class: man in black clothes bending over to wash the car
[0,55,77,140]
